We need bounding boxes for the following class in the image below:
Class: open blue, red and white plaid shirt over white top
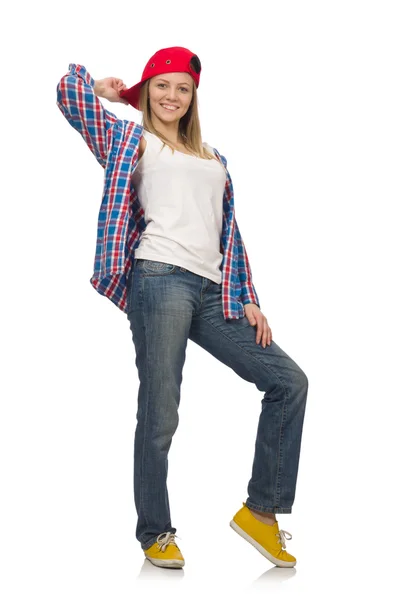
[57,63,260,319]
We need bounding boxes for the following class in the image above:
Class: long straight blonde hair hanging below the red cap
[139,79,215,159]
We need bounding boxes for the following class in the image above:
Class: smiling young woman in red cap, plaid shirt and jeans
[57,47,308,568]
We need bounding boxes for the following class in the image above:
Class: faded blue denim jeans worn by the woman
[127,258,308,550]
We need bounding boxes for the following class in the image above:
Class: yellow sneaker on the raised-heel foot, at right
[230,502,296,567]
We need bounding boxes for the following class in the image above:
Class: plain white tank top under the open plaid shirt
[132,130,226,283]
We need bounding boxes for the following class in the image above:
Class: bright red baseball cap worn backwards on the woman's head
[119,46,201,110]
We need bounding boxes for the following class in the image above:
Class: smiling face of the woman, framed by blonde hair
[149,73,194,123]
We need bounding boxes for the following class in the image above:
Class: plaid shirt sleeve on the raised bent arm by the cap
[57,63,119,168]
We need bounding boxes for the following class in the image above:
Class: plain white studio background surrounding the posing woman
[0,0,397,600]
